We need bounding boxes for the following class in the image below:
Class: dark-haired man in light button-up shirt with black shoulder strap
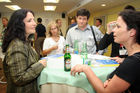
[66,9,103,54]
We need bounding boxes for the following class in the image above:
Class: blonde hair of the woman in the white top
[46,21,60,37]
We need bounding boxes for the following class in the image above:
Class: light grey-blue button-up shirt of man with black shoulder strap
[66,25,103,54]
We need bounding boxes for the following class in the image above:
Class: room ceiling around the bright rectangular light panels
[0,0,136,13]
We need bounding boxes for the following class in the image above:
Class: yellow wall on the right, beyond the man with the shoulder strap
[89,0,140,56]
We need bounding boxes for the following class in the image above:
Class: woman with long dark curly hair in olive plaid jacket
[2,9,46,93]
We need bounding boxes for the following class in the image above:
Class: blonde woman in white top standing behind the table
[43,22,65,56]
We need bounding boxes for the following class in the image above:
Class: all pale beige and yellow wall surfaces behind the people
[0,0,140,56]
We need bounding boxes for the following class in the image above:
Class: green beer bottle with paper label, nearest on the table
[64,44,71,71]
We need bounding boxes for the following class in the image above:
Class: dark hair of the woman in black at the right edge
[119,10,140,44]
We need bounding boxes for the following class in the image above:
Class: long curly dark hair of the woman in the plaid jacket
[2,9,34,52]
